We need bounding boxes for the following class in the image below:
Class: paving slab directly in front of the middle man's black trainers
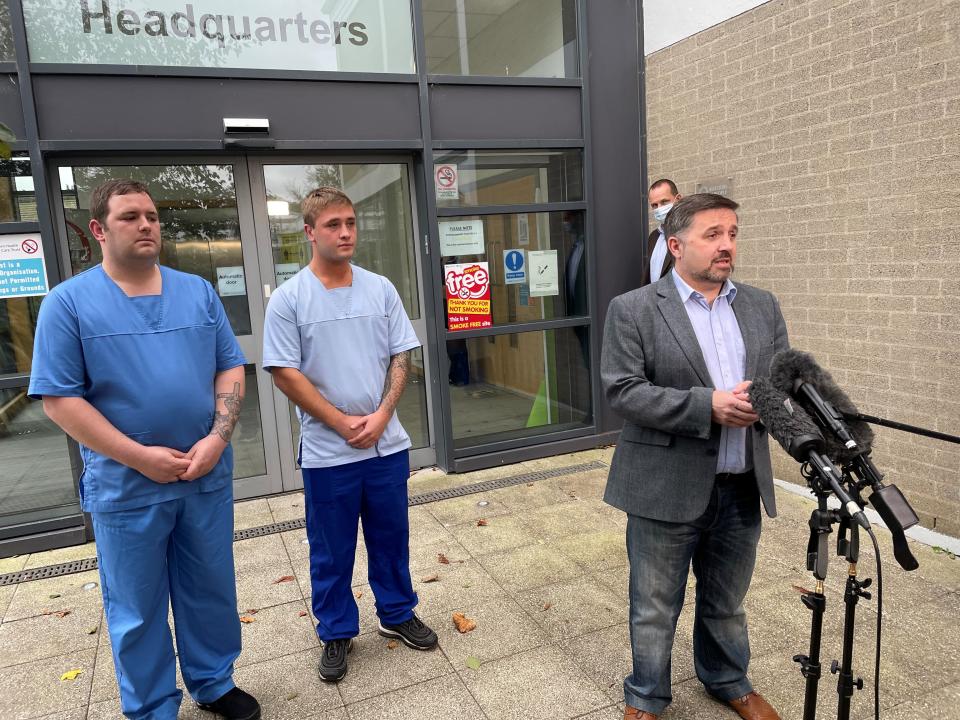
[337,633,453,714]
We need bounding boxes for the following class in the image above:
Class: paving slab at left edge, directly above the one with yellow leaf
[0,605,100,668]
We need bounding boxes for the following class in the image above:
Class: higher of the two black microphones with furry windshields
[770,349,873,463]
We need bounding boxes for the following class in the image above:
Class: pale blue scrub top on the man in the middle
[263,265,420,468]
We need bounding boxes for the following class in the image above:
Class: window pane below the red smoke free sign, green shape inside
[447,326,592,449]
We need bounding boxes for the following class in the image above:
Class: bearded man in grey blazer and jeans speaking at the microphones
[601,194,788,720]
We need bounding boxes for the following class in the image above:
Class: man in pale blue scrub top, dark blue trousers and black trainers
[263,187,437,682]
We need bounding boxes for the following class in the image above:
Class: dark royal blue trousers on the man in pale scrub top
[303,450,417,642]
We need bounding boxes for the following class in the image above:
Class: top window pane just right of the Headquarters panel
[423,0,580,78]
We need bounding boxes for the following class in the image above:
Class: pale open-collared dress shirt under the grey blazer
[672,270,753,473]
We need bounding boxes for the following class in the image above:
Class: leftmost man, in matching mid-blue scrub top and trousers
[29,180,260,720]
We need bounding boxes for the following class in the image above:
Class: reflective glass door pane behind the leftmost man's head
[60,165,251,335]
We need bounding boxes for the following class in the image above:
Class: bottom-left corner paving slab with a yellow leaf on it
[0,650,96,720]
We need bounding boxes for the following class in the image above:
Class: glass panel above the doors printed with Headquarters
[23,0,416,73]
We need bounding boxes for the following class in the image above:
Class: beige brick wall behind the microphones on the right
[647,0,960,536]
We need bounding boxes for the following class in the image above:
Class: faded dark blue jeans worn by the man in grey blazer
[623,473,760,715]
